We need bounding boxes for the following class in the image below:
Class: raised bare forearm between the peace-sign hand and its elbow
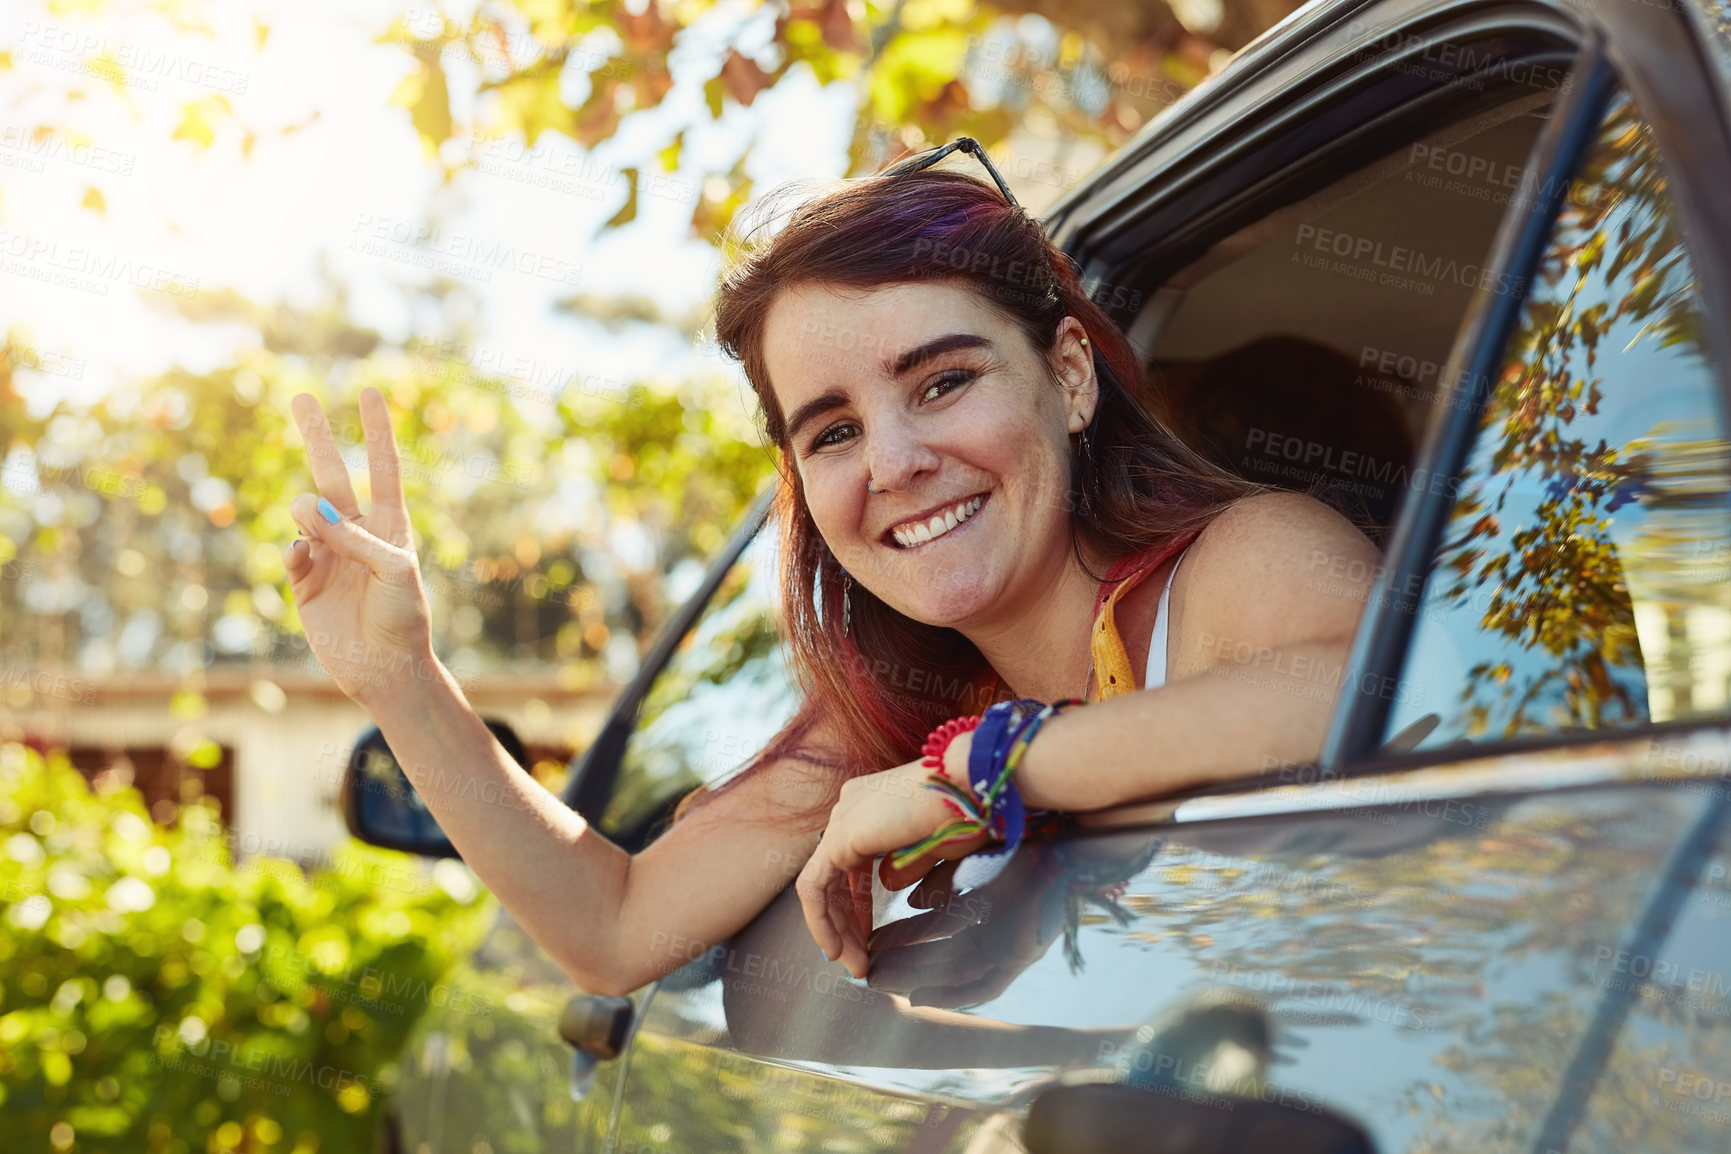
[370,661,630,993]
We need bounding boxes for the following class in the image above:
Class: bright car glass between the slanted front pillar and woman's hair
[599,521,800,837]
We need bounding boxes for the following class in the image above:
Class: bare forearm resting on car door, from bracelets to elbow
[1016,642,1347,811]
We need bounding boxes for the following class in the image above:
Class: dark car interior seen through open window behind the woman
[1130,87,1554,545]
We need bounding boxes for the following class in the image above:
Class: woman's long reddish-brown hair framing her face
[680,170,1265,827]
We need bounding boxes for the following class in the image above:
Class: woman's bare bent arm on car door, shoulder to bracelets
[1016,493,1380,810]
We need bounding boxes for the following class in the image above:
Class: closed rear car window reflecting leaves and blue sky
[1388,95,1731,746]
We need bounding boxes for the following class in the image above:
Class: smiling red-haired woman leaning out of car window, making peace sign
[286,144,1376,993]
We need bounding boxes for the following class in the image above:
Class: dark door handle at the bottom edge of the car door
[1023,1081,1376,1154]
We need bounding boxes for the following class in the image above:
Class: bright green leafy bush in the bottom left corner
[0,744,492,1154]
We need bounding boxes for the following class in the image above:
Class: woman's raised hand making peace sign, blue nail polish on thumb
[282,388,438,713]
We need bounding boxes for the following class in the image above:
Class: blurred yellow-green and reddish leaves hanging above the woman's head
[383,0,1298,240]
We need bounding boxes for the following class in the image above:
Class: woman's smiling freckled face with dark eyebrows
[763,282,1096,628]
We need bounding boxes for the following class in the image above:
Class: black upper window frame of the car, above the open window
[1049,3,1589,297]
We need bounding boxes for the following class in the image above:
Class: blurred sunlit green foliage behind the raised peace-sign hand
[0,296,772,687]
